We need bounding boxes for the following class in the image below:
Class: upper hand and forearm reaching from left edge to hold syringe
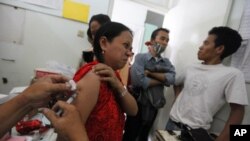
[0,75,70,137]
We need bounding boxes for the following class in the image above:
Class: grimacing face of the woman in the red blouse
[101,31,133,70]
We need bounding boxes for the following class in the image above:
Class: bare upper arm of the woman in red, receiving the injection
[73,71,100,124]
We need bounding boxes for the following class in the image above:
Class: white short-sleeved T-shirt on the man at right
[170,64,248,129]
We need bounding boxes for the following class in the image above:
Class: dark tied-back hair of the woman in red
[94,22,132,63]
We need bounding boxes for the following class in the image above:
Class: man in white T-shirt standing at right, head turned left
[166,27,248,141]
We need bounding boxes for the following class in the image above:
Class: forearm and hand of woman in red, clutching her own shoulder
[93,64,138,115]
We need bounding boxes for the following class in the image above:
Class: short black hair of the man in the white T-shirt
[208,26,242,60]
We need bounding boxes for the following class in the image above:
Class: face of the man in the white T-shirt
[198,34,221,63]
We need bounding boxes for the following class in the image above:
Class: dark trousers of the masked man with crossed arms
[123,103,158,141]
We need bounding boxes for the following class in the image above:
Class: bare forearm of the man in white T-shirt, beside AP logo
[215,103,245,141]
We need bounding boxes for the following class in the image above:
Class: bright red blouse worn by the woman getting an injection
[73,61,125,141]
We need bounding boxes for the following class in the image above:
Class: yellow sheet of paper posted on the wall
[63,0,89,23]
